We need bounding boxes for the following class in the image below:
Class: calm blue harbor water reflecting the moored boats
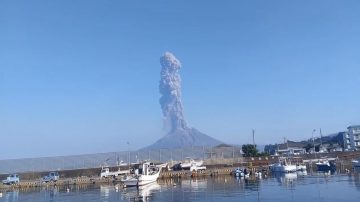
[0,172,360,202]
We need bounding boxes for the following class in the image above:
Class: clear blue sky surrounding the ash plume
[0,0,360,159]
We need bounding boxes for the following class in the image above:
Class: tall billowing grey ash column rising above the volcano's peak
[159,52,187,133]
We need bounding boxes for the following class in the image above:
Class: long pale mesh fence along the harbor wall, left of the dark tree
[0,146,242,174]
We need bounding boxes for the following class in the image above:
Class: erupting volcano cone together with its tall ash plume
[146,52,221,149]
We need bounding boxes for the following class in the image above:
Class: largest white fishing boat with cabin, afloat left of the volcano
[121,162,161,187]
